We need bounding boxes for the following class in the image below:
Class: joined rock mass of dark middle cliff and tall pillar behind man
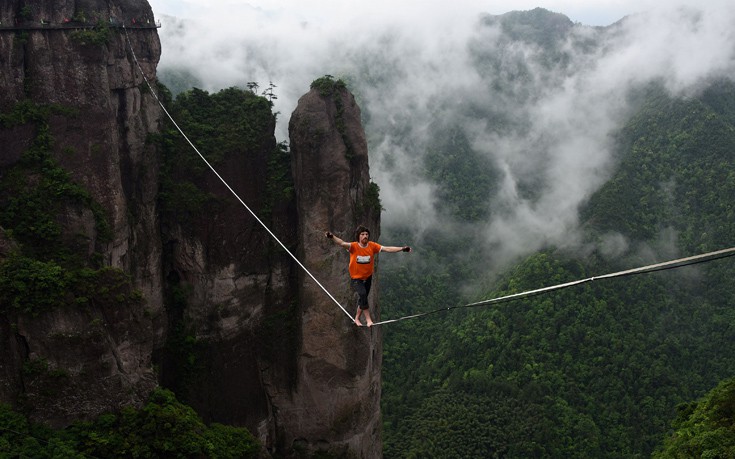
[157,83,382,458]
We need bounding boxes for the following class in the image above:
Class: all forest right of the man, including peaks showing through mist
[368,10,735,458]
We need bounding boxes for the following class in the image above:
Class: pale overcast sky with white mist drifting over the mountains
[144,0,735,280]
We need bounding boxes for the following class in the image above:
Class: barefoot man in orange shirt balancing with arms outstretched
[325,225,411,327]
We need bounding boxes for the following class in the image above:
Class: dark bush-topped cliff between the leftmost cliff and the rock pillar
[156,90,298,449]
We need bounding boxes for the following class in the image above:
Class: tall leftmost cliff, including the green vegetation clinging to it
[0,0,163,425]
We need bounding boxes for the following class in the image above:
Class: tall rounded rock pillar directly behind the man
[284,81,382,458]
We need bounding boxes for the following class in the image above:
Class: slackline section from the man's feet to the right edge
[374,247,735,325]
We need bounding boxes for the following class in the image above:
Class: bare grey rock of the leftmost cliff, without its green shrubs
[0,0,165,426]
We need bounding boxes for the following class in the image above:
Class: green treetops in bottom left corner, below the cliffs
[0,389,260,459]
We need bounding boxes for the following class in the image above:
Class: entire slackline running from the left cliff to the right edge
[122,25,735,325]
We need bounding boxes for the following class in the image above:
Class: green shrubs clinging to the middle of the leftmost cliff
[0,101,141,314]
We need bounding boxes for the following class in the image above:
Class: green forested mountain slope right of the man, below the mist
[383,81,735,458]
